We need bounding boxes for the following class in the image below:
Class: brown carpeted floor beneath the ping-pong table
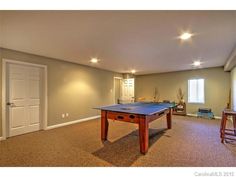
[0,116,236,167]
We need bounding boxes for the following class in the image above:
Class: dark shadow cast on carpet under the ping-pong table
[92,129,167,167]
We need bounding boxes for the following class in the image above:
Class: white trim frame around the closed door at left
[2,58,48,140]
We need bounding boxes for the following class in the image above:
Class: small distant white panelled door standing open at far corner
[122,78,134,103]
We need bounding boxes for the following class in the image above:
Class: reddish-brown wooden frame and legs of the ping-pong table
[101,108,172,154]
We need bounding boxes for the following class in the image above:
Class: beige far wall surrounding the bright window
[135,67,230,116]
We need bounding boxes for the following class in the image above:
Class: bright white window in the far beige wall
[188,79,205,103]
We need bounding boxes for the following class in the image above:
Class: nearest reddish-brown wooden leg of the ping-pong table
[139,116,149,154]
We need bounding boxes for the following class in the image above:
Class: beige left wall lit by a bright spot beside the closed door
[0,49,122,136]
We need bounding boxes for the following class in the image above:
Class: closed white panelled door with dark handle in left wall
[7,64,41,136]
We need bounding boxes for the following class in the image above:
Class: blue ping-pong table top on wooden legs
[96,102,175,115]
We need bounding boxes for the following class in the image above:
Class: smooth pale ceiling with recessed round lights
[0,11,236,74]
